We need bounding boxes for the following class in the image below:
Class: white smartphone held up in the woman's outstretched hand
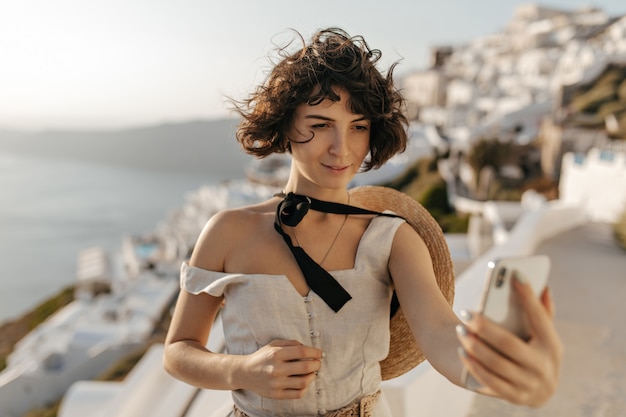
[462,255,550,390]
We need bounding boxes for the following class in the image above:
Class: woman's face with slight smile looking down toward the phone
[288,90,370,193]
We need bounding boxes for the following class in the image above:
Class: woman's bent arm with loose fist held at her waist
[163,212,322,398]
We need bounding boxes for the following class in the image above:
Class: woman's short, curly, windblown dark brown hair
[233,28,408,171]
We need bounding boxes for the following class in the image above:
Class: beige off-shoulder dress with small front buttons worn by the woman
[181,216,404,417]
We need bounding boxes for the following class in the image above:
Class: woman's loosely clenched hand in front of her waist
[236,340,322,399]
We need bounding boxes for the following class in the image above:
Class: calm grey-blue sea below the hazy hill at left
[0,152,218,324]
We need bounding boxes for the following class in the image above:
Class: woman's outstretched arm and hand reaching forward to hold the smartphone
[389,225,562,406]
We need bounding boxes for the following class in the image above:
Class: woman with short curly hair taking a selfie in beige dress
[164,29,561,417]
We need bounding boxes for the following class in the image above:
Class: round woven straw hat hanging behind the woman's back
[350,185,454,380]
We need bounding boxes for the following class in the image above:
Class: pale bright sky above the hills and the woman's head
[0,0,626,130]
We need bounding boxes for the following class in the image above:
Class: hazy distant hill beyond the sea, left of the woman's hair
[0,119,252,179]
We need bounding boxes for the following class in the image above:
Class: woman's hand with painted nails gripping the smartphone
[457,272,563,407]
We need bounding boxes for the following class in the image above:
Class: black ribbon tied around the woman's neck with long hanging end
[274,193,400,316]
